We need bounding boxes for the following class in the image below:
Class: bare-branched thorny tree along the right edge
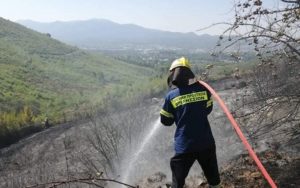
[213,0,300,148]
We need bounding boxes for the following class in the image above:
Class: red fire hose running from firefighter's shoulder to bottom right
[199,81,277,188]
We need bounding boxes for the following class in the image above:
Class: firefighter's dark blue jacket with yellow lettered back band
[160,82,215,154]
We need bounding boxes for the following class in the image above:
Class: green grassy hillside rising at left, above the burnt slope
[0,18,153,124]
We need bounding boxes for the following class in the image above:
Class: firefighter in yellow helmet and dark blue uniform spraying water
[160,57,220,188]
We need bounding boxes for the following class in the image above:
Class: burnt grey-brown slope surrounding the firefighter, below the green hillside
[0,89,300,188]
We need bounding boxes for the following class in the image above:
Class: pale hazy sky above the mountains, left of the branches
[0,0,274,34]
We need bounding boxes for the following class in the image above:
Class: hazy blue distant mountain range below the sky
[18,19,218,50]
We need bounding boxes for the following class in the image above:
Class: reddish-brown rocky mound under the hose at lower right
[221,150,300,188]
